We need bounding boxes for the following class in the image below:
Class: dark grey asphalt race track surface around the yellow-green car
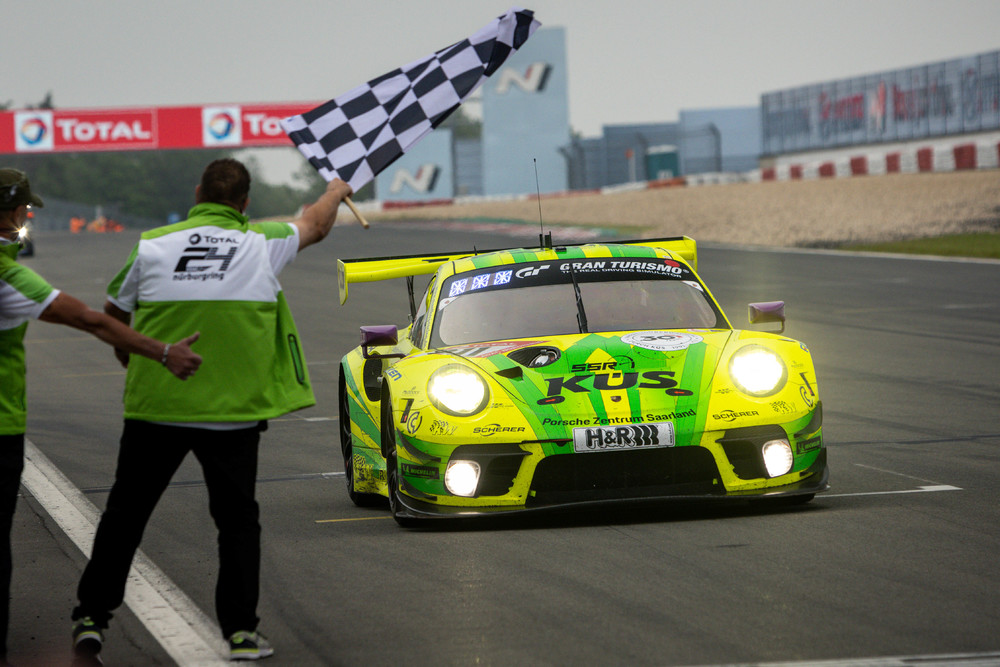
[10,222,1000,667]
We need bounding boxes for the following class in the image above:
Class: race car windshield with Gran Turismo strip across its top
[431,258,727,347]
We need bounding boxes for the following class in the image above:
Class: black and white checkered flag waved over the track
[281,7,541,192]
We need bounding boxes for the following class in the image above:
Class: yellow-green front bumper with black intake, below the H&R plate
[397,405,829,518]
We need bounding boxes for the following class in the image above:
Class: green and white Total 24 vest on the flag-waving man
[108,204,316,422]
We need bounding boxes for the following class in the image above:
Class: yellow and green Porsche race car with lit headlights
[338,235,828,526]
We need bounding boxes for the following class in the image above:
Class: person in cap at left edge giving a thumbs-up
[0,168,201,664]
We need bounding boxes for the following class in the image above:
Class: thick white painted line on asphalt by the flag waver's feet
[21,438,229,667]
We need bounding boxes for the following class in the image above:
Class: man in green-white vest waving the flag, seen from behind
[73,158,351,660]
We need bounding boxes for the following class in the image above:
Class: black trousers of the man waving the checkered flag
[73,420,266,637]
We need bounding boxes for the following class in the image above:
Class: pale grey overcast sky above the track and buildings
[0,0,1000,183]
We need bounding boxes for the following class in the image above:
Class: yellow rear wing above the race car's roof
[337,236,698,305]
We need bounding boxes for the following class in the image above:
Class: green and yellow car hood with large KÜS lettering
[438,330,734,446]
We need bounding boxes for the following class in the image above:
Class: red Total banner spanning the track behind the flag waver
[0,102,317,154]
